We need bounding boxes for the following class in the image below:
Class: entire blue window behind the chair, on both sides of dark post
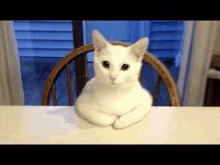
[14,20,184,105]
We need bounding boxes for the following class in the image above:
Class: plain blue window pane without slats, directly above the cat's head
[85,21,149,43]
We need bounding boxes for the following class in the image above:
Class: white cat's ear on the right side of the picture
[130,37,149,61]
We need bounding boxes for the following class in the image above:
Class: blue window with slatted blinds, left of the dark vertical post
[14,20,73,105]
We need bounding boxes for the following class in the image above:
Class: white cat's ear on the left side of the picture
[92,30,109,51]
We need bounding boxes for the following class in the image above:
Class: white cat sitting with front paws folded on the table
[75,31,153,129]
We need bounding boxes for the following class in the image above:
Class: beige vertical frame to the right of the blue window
[178,21,218,106]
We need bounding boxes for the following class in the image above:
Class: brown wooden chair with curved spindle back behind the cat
[41,41,182,106]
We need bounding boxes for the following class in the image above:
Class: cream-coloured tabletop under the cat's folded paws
[0,106,220,144]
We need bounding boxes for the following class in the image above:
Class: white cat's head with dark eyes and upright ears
[93,30,149,87]
